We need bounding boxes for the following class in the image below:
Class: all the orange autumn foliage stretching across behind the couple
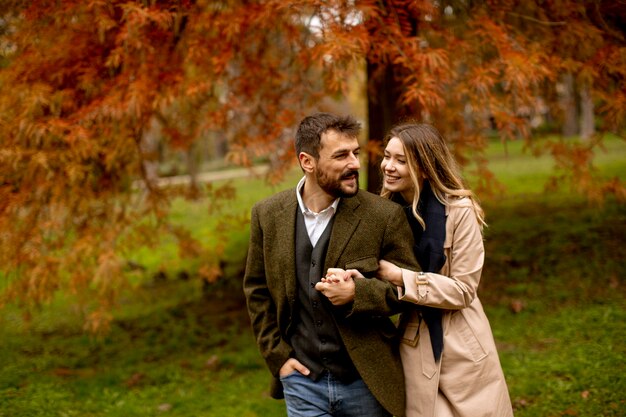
[0,0,626,329]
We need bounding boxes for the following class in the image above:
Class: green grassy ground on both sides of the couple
[0,135,626,417]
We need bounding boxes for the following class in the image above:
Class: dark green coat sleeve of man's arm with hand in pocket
[243,206,293,376]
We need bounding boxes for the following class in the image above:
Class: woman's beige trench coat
[399,198,513,417]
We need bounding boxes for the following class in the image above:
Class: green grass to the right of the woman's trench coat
[480,199,626,417]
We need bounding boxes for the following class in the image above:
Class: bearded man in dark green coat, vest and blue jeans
[243,113,417,417]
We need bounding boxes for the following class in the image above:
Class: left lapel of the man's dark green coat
[273,191,298,308]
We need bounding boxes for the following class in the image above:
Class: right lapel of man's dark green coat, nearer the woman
[324,196,361,269]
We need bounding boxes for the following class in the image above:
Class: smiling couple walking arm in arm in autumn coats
[243,113,513,417]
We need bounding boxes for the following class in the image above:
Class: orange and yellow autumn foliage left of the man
[0,1,322,328]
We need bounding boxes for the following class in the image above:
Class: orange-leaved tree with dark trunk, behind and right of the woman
[365,0,626,193]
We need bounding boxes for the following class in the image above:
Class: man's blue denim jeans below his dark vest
[280,371,391,417]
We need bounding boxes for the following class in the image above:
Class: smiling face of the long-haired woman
[380,137,414,195]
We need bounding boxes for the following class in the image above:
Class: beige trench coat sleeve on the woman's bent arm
[398,201,485,310]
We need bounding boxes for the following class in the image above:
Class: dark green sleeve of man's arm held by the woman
[350,206,417,316]
